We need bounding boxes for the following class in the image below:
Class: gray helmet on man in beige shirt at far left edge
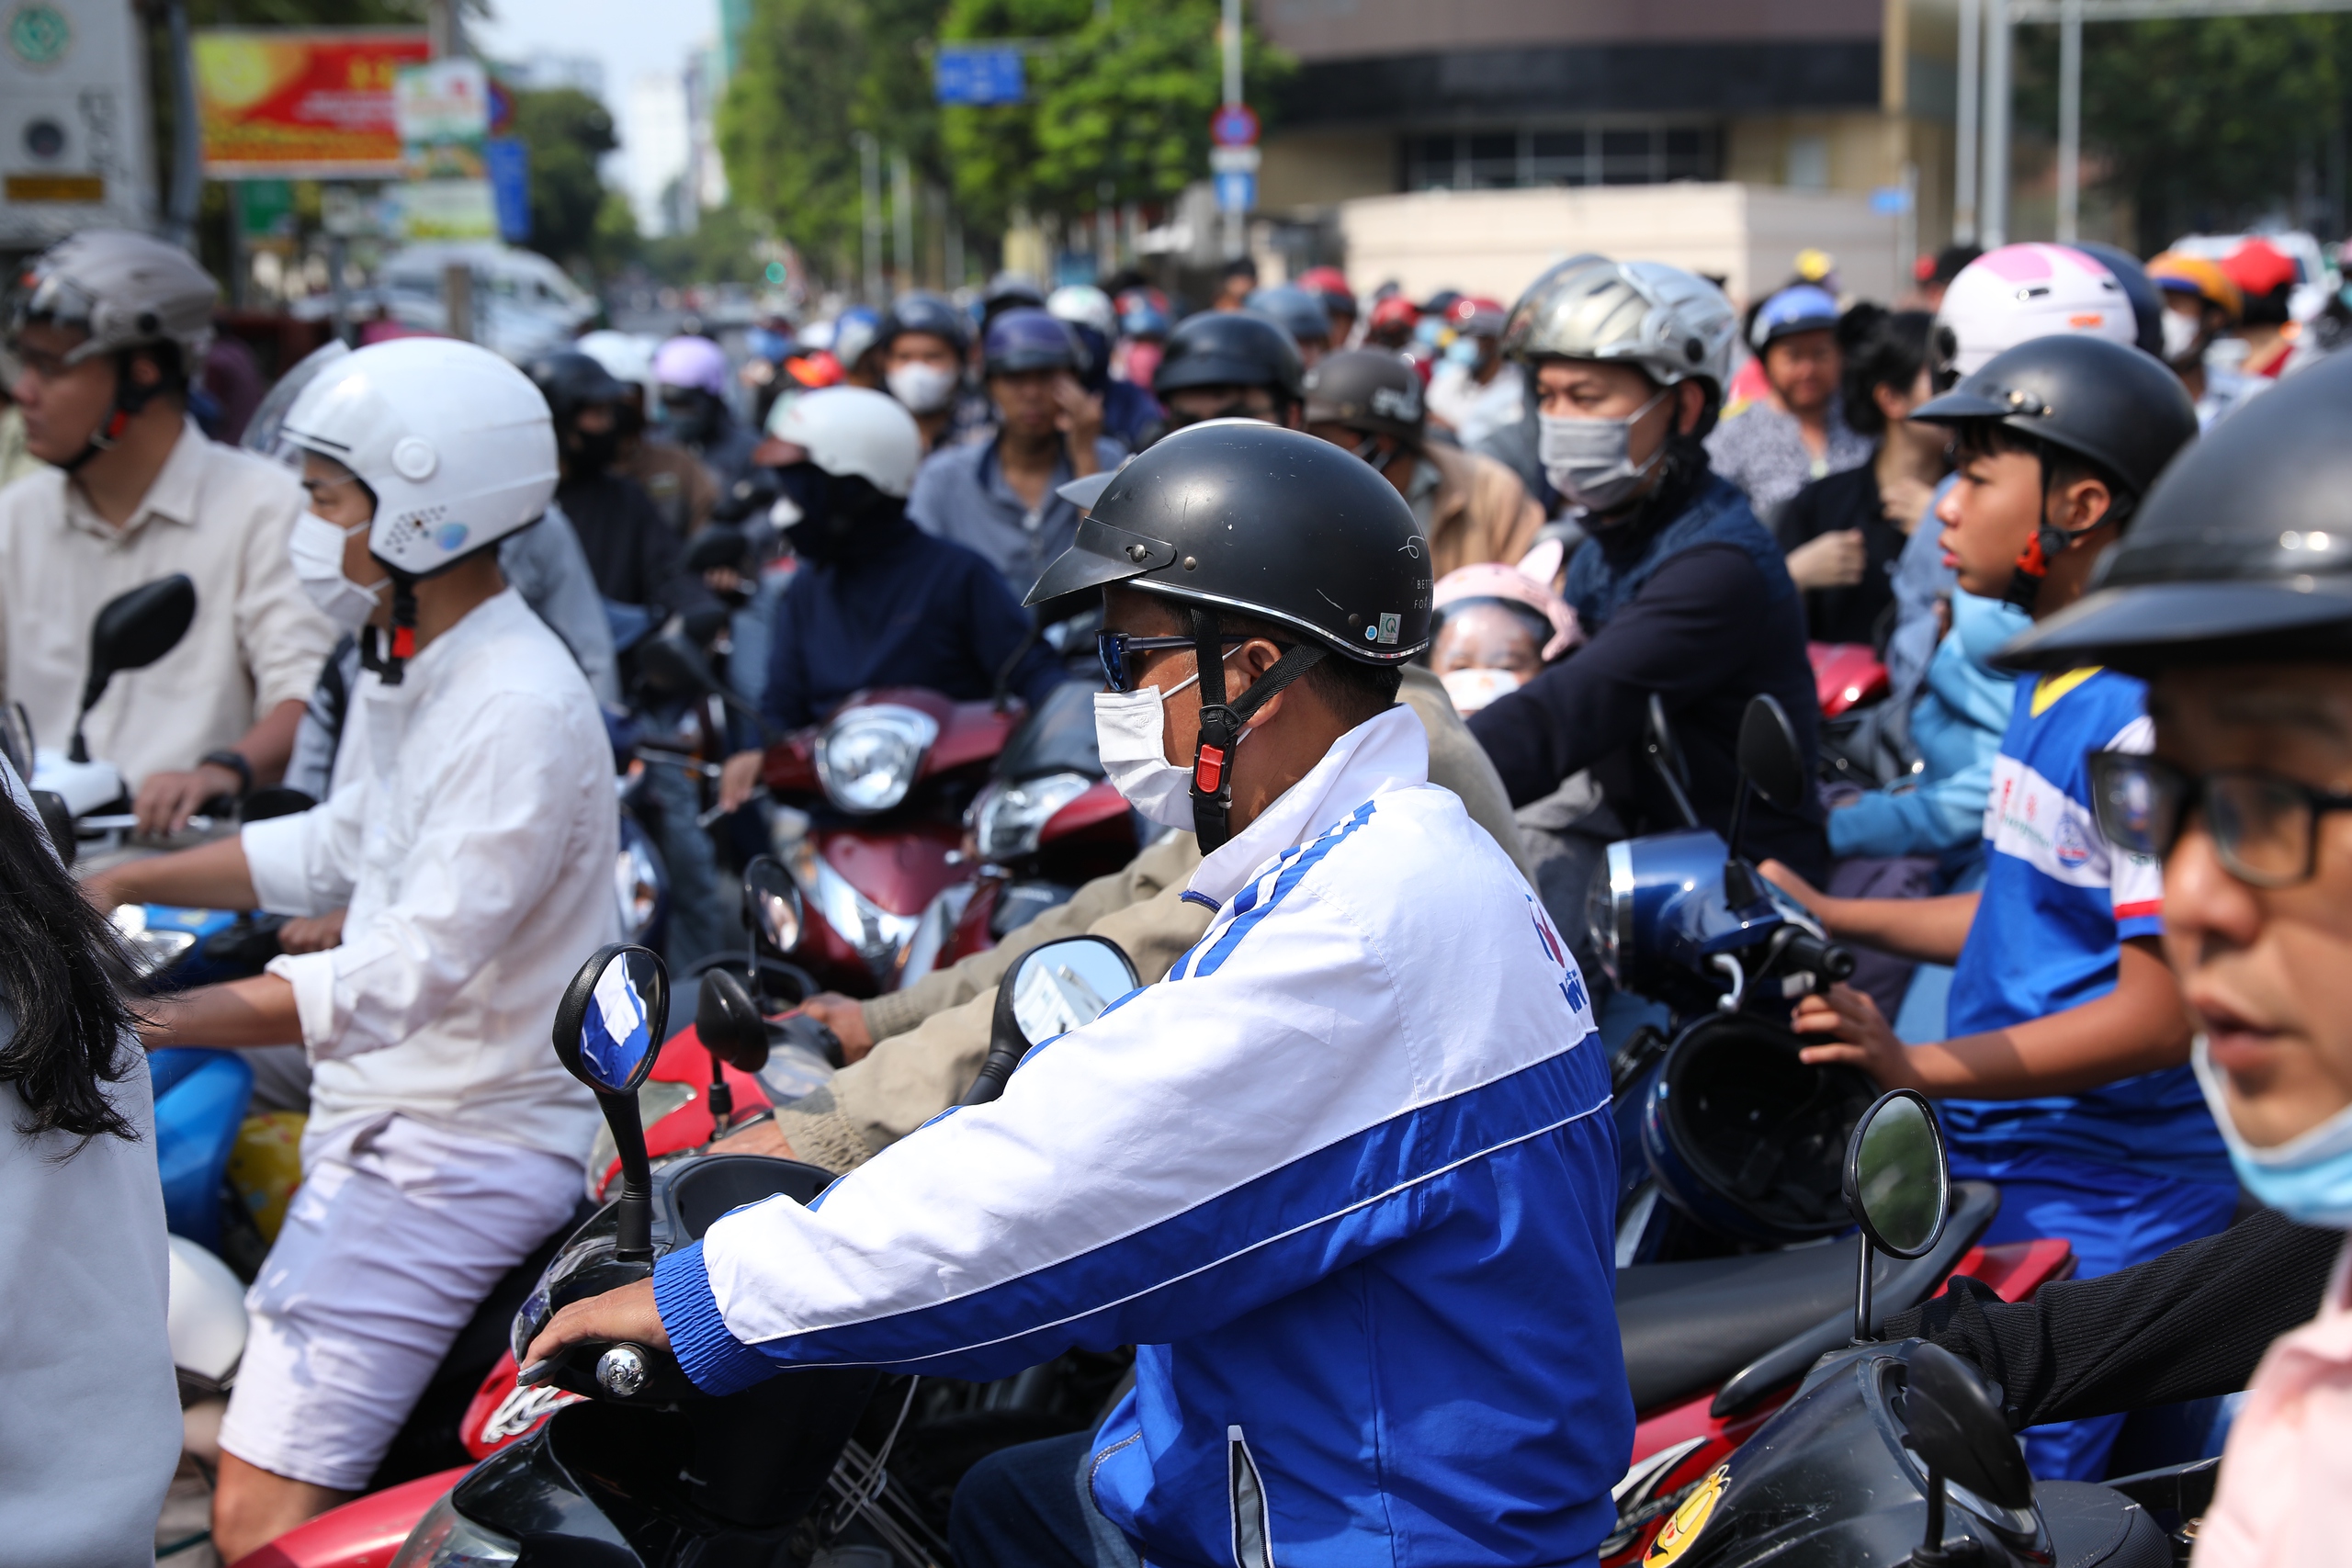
[9,228,221,376]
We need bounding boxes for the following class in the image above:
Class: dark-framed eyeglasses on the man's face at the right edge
[2091,752,2352,888]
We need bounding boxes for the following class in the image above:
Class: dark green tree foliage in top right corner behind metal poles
[2018,14,2352,254]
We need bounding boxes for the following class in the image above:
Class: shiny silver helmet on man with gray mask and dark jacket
[1503,254,1740,419]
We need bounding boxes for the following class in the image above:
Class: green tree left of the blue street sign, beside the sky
[718,0,945,277]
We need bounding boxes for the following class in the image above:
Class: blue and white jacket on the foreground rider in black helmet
[654,707,1633,1568]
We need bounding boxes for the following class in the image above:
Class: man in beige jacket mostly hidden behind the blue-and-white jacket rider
[724,665,1533,1170]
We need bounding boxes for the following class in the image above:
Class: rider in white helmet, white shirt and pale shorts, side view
[89,339,621,1559]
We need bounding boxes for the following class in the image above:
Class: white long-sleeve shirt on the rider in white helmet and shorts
[243,590,621,1159]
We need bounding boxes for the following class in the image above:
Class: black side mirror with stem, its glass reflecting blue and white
[555,942,671,1262]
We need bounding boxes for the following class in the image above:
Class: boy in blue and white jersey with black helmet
[1767,336,2237,1479]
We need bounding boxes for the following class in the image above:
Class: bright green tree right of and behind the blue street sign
[941,0,1294,231]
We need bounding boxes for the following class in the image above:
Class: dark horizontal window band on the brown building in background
[1399,125,1724,190]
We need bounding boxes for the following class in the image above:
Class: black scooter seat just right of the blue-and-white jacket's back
[1618,1236,1853,1416]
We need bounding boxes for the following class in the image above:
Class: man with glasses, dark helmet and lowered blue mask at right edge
[1889,341,2352,1568]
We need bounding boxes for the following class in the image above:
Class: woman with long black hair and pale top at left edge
[0,757,181,1568]
